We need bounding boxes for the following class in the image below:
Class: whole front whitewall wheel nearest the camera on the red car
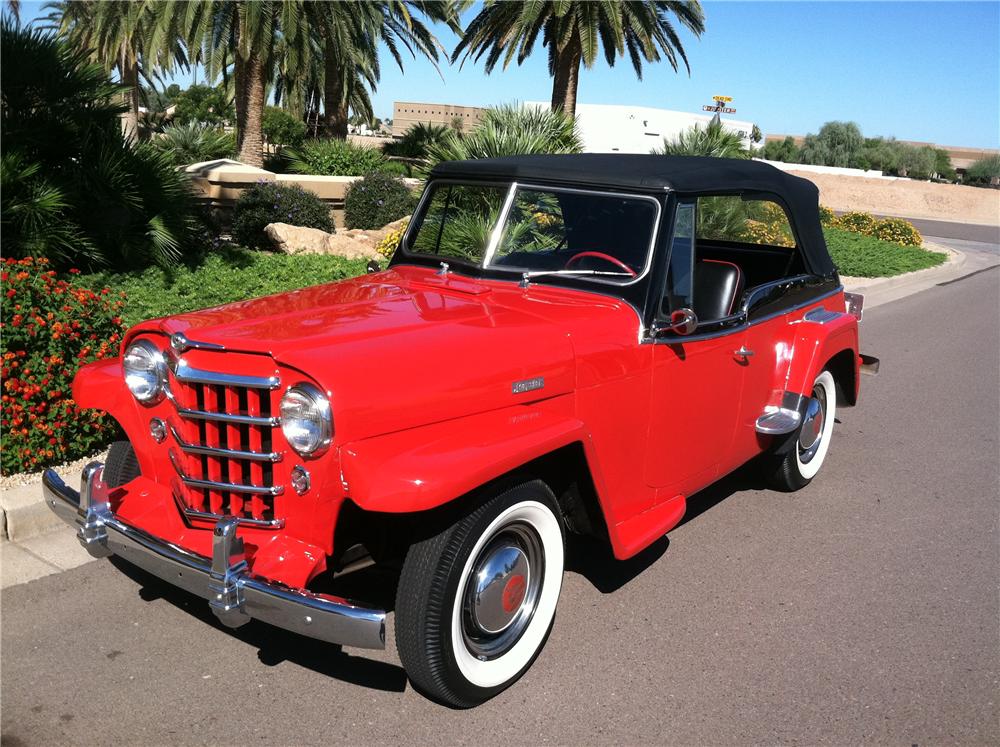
[396,480,564,708]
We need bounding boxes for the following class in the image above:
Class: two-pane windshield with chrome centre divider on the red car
[407,183,659,283]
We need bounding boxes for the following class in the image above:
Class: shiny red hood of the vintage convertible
[133,266,635,443]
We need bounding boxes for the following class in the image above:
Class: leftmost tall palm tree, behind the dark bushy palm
[47,0,188,142]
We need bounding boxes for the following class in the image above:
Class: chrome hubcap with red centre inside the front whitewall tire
[462,523,545,661]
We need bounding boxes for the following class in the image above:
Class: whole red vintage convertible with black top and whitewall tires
[44,154,877,706]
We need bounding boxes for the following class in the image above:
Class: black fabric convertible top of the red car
[431,153,836,275]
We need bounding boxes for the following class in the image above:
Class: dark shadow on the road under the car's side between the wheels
[566,462,766,594]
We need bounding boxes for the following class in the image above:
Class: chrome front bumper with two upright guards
[42,462,385,648]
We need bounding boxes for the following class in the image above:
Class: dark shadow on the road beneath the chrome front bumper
[110,557,406,692]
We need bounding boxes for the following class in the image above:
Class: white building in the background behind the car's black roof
[525,101,753,153]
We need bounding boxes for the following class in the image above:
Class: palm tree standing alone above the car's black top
[452,0,705,116]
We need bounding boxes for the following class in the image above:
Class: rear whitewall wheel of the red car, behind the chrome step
[765,371,837,492]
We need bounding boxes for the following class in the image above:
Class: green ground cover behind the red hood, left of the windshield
[78,249,376,326]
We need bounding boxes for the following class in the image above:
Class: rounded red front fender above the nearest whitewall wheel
[341,405,601,513]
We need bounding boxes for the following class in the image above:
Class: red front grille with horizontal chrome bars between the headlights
[167,351,284,528]
